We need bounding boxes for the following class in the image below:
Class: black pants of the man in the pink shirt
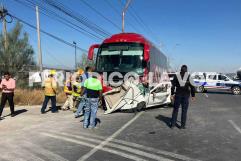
[0,93,14,117]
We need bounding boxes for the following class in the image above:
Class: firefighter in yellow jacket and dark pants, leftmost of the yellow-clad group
[41,71,58,114]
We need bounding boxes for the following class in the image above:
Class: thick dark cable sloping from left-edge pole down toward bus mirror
[9,14,87,52]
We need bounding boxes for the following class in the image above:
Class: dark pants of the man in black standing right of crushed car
[171,96,189,127]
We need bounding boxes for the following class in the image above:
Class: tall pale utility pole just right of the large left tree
[36,6,43,72]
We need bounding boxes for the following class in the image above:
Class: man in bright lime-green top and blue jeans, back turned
[82,76,102,128]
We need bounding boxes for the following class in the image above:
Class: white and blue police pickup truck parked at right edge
[192,73,241,95]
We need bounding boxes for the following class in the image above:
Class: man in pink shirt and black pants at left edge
[0,72,16,120]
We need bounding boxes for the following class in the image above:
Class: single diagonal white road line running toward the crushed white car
[78,111,144,161]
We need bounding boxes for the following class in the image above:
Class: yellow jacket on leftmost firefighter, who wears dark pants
[44,78,57,96]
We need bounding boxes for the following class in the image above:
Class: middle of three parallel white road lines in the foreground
[52,133,171,161]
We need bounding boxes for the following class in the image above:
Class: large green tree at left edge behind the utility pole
[0,22,35,75]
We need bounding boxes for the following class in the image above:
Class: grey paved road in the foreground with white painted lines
[0,92,241,161]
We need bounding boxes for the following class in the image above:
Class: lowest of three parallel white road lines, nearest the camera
[41,133,147,161]
